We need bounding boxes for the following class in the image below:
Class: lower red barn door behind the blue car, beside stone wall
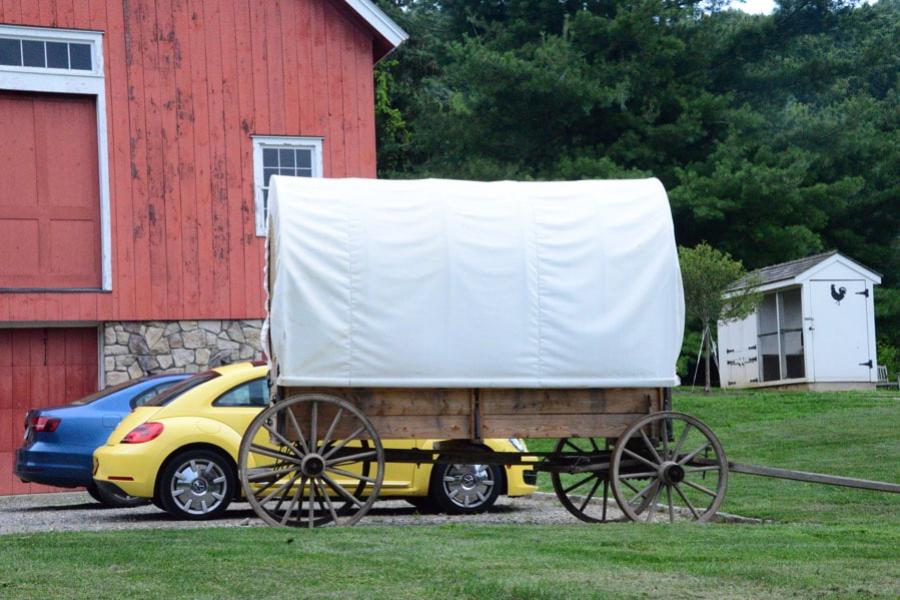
[0,327,97,495]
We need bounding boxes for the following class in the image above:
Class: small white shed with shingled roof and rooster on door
[718,251,881,390]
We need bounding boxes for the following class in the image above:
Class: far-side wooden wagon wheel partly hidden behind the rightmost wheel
[550,438,650,523]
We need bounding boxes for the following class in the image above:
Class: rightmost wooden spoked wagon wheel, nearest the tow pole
[610,412,728,522]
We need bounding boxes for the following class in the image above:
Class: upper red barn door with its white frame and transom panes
[0,25,112,290]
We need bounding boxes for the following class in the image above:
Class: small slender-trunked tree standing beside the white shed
[678,243,760,392]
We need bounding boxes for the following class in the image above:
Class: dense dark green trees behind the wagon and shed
[378,0,900,366]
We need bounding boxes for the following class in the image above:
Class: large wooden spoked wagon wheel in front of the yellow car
[239,394,384,527]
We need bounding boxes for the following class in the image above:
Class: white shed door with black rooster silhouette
[809,279,872,381]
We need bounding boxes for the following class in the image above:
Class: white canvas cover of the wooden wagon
[267,177,684,388]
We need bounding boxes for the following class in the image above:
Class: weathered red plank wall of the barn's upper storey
[0,0,375,323]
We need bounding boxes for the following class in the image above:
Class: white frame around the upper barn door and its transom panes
[0,25,112,291]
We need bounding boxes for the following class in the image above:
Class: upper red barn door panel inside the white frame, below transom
[0,90,100,289]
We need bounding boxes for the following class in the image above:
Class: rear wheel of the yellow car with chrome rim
[156,450,237,521]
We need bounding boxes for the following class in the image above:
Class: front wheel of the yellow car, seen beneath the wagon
[428,464,503,515]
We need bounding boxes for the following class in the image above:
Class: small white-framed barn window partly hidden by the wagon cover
[253,136,322,236]
